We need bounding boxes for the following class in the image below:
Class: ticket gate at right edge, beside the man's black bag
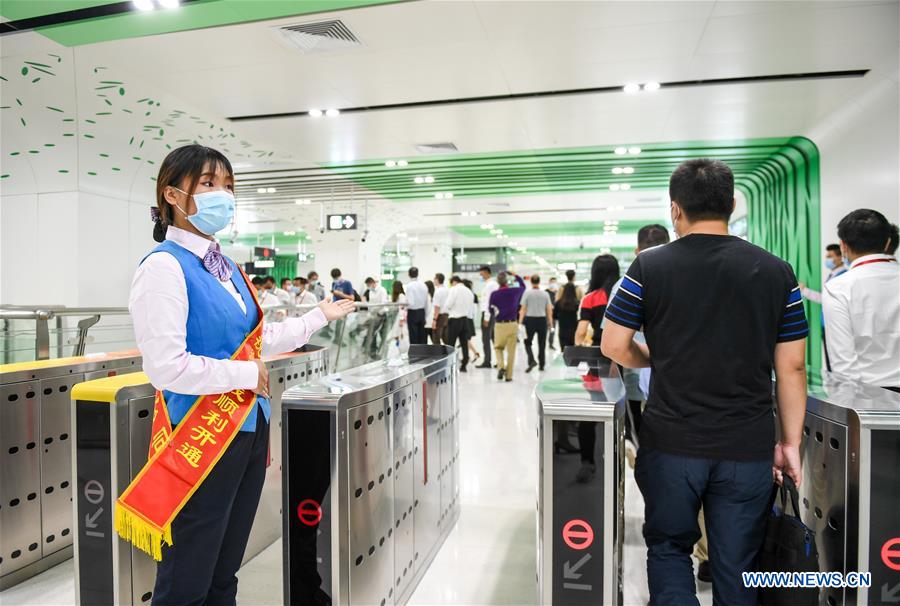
[788,373,900,606]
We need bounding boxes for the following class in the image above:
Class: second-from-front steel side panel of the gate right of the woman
[392,385,423,595]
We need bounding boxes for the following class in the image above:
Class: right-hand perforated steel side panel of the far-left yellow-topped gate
[39,375,84,555]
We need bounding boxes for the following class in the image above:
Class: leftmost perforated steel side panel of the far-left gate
[0,381,43,576]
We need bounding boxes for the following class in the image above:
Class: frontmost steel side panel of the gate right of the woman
[347,398,399,604]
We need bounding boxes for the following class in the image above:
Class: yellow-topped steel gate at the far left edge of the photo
[0,351,141,589]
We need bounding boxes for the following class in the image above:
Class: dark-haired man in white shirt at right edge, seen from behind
[822,209,900,391]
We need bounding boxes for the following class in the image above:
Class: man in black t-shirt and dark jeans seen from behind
[601,160,808,606]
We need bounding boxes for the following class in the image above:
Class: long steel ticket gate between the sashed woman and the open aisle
[282,345,459,606]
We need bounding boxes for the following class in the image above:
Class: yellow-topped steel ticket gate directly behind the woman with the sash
[71,345,327,606]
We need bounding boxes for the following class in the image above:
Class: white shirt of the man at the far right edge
[822,255,900,387]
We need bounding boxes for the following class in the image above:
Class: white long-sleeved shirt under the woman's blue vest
[128,226,328,395]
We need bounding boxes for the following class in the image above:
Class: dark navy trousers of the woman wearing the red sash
[153,410,269,606]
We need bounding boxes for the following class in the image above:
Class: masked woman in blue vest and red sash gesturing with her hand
[115,145,354,606]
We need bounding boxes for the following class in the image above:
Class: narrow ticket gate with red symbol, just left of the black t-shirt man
[535,347,625,606]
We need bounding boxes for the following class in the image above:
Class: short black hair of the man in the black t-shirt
[669,158,734,221]
